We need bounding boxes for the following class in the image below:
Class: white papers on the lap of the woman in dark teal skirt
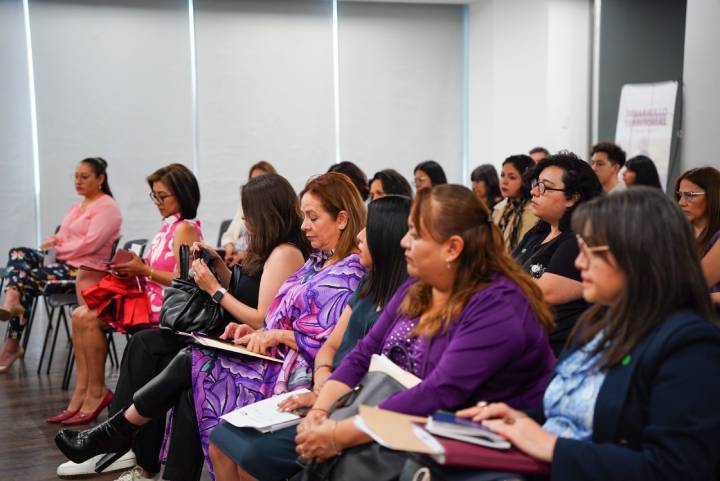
[220,389,310,433]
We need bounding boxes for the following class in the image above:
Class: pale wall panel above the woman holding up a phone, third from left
[195,0,335,242]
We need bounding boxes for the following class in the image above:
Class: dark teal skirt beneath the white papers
[210,422,301,481]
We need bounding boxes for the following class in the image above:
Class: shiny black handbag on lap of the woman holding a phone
[160,245,228,335]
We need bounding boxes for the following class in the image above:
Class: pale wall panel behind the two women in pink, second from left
[30,0,192,240]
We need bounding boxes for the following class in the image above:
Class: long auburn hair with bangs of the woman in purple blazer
[400,184,555,338]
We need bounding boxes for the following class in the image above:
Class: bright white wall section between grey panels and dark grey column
[469,0,591,169]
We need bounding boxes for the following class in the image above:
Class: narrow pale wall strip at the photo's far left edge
[0,2,37,262]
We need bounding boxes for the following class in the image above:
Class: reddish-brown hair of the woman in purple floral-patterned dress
[300,172,366,259]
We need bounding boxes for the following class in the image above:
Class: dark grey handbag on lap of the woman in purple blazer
[292,346,410,481]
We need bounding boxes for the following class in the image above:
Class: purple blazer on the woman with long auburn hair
[331,276,555,416]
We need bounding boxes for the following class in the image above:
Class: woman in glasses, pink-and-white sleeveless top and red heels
[47,164,202,426]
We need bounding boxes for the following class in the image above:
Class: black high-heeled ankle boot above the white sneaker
[55,411,140,463]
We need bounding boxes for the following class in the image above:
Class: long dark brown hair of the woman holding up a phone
[240,174,310,275]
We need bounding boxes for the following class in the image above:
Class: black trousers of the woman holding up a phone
[110,329,190,473]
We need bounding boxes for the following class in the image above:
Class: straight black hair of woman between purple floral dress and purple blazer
[359,195,412,308]
